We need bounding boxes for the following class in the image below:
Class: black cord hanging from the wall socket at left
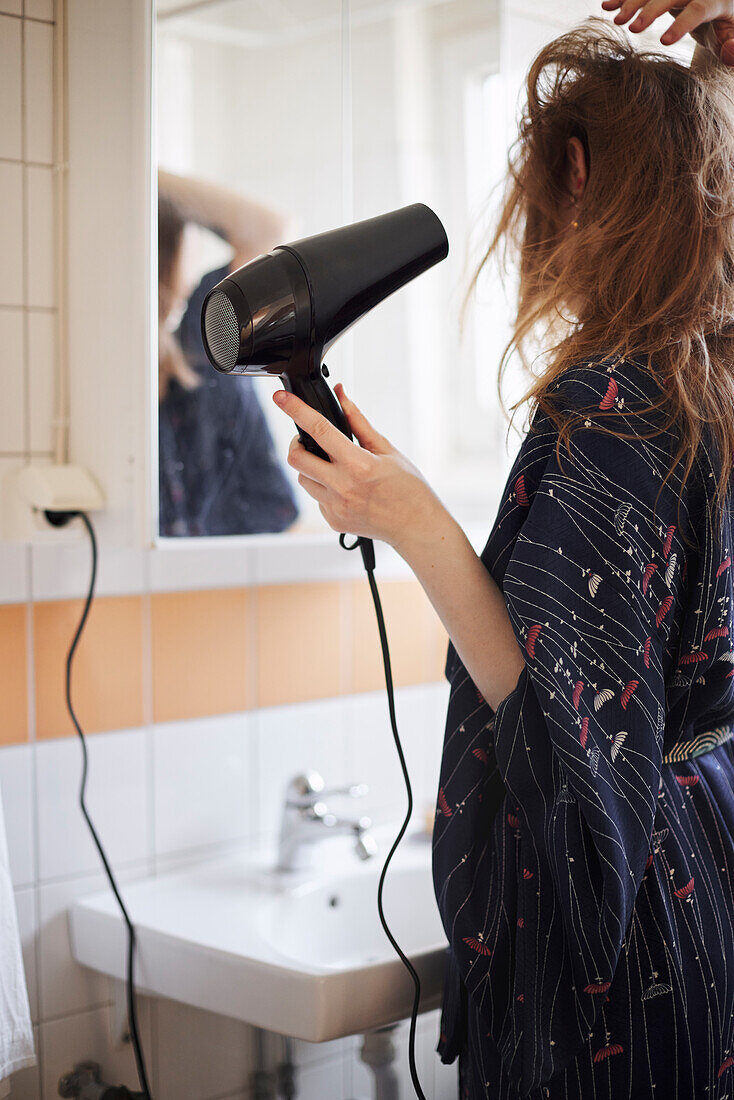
[44,512,152,1100]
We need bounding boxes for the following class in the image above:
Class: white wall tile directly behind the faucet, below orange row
[255,696,352,836]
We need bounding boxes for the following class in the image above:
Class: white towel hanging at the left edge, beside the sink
[0,787,35,1097]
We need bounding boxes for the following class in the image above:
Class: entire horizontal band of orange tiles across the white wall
[0,579,448,746]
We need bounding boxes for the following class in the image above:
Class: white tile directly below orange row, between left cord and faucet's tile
[151,714,253,855]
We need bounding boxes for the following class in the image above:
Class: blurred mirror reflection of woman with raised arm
[158,172,298,536]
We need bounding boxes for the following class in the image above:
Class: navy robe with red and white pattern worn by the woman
[434,360,734,1100]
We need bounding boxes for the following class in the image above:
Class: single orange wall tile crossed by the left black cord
[33,596,143,739]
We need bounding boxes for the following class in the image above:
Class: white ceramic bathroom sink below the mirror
[69,827,447,1043]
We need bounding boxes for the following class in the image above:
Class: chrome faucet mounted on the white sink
[276,771,377,871]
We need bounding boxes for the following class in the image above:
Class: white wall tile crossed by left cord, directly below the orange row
[36,729,151,881]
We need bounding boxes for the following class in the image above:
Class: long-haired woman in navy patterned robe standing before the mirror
[274,0,734,1100]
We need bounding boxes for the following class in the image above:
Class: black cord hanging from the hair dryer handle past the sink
[339,535,426,1100]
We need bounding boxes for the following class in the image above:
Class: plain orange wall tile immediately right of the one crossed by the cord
[151,589,253,722]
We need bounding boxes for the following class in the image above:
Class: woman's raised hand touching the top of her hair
[602,0,734,65]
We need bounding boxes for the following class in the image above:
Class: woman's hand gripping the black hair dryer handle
[273,383,445,552]
